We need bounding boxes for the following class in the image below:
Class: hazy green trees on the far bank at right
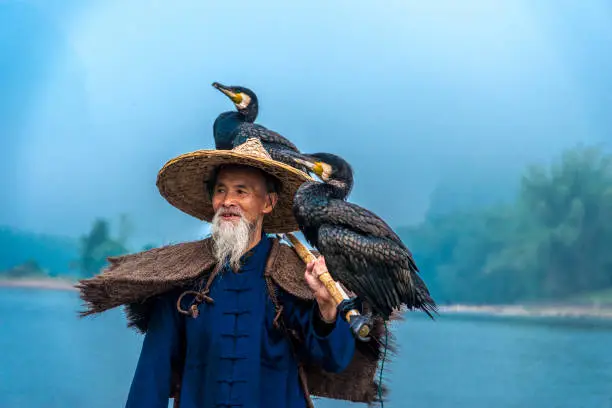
[399,147,612,303]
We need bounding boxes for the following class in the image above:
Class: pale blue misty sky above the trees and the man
[0,0,612,244]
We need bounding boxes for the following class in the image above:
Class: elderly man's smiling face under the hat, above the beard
[212,167,276,225]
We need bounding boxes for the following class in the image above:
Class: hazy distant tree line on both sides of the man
[0,147,612,296]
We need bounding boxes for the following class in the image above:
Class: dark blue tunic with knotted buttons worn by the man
[126,235,355,408]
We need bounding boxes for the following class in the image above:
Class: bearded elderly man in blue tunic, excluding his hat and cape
[127,147,354,408]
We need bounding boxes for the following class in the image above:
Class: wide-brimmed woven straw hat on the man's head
[157,138,313,233]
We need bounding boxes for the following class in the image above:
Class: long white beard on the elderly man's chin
[210,209,254,271]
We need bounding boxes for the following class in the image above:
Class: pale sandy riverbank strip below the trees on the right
[439,303,612,319]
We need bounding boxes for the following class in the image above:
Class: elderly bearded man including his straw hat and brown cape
[77,140,378,408]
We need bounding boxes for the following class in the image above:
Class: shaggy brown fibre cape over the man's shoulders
[76,238,393,404]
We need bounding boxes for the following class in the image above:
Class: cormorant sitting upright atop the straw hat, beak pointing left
[212,82,307,171]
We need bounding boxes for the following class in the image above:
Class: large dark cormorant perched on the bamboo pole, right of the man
[293,153,437,320]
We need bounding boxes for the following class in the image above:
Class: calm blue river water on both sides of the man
[0,288,612,408]
